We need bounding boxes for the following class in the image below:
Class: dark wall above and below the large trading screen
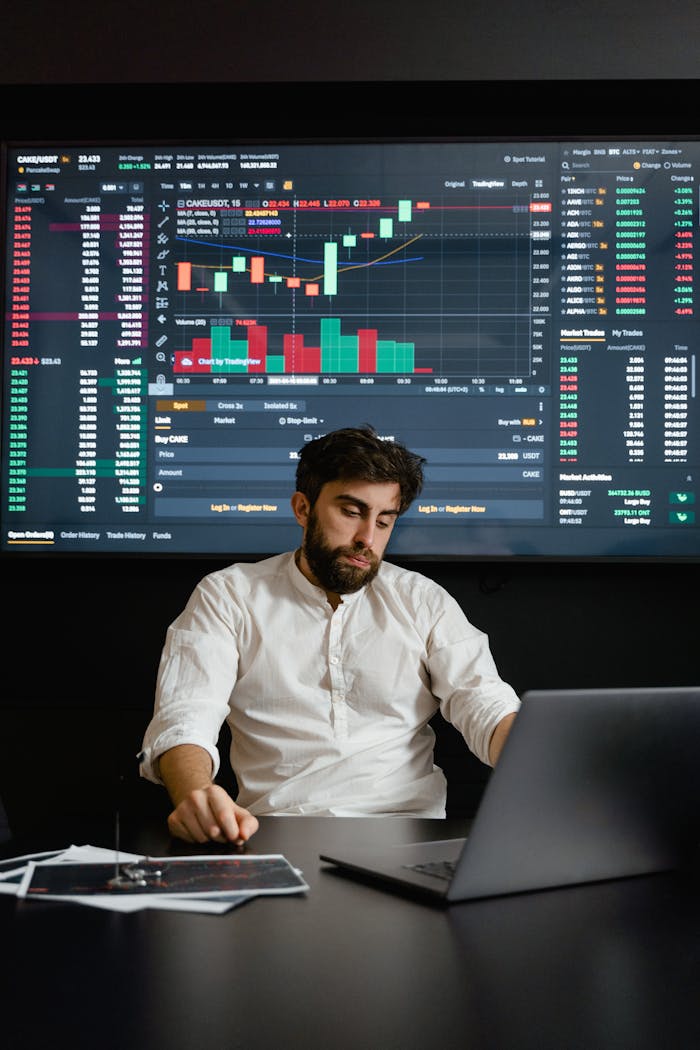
[0,0,700,830]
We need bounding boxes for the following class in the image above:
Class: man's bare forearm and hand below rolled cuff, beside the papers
[160,743,258,843]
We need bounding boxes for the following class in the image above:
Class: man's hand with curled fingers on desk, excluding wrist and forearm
[168,783,258,843]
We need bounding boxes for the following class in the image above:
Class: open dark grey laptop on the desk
[320,687,700,902]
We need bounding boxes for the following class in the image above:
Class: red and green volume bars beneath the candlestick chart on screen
[174,317,432,375]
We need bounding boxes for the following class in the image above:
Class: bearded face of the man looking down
[295,481,401,594]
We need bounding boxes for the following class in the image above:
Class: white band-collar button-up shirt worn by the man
[141,553,519,817]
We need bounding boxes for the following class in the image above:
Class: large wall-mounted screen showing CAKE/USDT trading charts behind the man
[0,125,700,560]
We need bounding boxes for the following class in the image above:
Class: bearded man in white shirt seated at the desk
[140,426,519,843]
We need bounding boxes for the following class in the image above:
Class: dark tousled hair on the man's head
[296,424,426,515]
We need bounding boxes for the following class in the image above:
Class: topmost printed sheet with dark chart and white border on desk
[18,854,309,900]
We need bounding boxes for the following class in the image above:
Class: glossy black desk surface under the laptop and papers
[0,817,700,1050]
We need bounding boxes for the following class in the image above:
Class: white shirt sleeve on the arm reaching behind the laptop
[421,594,521,765]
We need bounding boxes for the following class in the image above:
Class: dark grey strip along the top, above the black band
[0,0,700,84]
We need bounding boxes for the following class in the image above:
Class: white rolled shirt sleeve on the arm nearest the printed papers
[140,579,243,783]
